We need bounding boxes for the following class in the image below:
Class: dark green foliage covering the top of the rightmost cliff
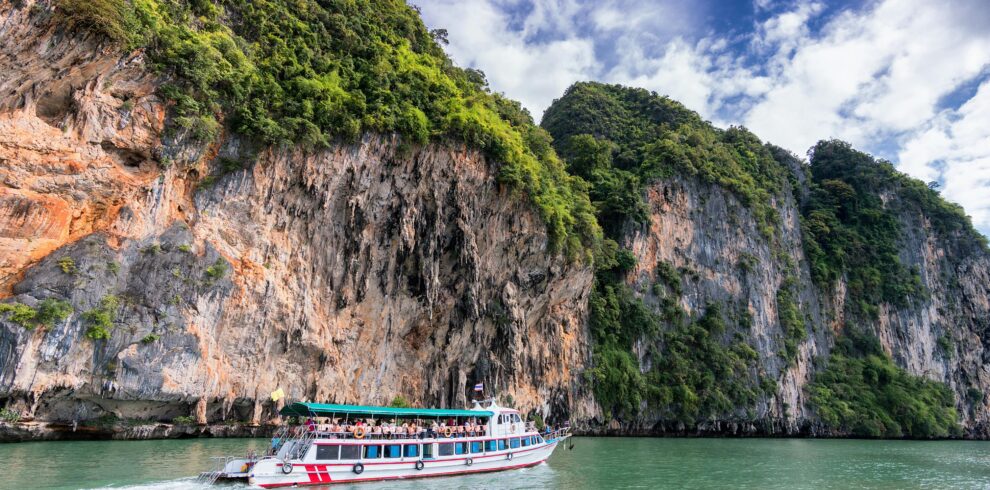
[802,141,986,318]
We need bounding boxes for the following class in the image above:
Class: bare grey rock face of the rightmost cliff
[876,203,990,439]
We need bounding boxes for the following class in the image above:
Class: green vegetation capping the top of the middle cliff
[541,82,790,238]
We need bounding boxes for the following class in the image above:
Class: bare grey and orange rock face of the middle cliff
[600,173,832,434]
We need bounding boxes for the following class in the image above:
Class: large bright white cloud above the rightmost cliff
[743,0,990,232]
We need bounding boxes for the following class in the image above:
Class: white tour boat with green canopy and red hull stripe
[200,402,570,488]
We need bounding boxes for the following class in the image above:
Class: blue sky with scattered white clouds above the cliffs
[411,0,990,235]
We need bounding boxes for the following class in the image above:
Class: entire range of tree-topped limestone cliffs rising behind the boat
[0,0,990,437]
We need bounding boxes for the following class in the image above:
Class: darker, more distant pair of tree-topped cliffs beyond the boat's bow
[543,83,990,437]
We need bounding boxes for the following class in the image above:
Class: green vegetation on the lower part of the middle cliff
[586,260,775,426]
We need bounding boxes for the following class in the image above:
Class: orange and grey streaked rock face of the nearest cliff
[0,3,592,432]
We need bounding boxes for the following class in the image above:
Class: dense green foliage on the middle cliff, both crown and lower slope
[542,83,784,425]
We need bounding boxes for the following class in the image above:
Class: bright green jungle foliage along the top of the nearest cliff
[54,0,600,258]
